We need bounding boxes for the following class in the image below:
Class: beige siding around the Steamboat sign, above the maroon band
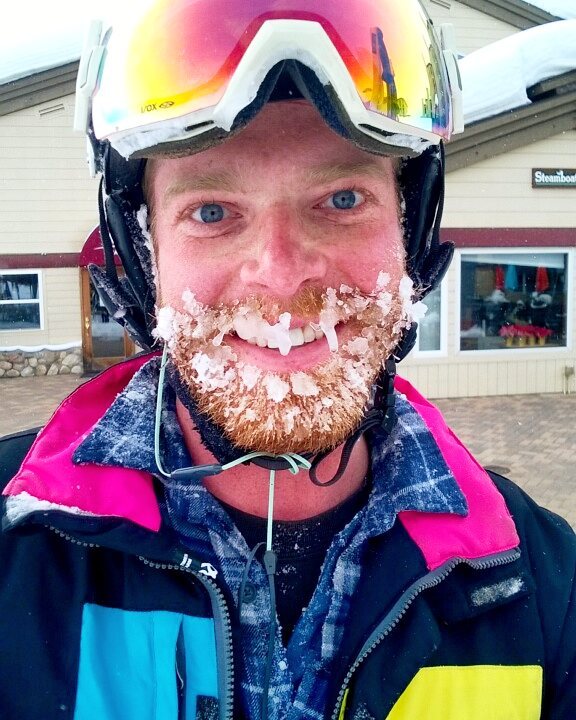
[443,131,576,228]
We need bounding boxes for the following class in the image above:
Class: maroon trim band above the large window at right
[440,228,576,248]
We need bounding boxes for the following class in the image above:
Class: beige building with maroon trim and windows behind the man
[0,0,576,397]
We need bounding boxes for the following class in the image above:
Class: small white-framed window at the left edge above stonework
[0,270,42,330]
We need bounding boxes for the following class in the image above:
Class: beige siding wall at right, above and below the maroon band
[401,132,576,397]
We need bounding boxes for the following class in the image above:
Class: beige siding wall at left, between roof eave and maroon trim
[0,95,97,254]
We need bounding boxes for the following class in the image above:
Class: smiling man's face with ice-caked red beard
[148,101,409,453]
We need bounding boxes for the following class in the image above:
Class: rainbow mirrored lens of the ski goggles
[94,0,451,137]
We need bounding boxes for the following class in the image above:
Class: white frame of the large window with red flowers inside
[454,245,574,359]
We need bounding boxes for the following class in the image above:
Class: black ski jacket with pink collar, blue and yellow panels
[0,358,576,720]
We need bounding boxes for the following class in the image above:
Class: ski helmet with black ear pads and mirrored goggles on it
[75,0,462,472]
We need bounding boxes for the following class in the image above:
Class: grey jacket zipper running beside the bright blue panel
[46,525,234,720]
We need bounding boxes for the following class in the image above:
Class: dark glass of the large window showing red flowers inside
[460,251,568,350]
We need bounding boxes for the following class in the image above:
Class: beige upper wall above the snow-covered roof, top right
[423,0,519,55]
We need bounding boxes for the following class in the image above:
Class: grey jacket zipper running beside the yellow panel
[331,549,520,720]
